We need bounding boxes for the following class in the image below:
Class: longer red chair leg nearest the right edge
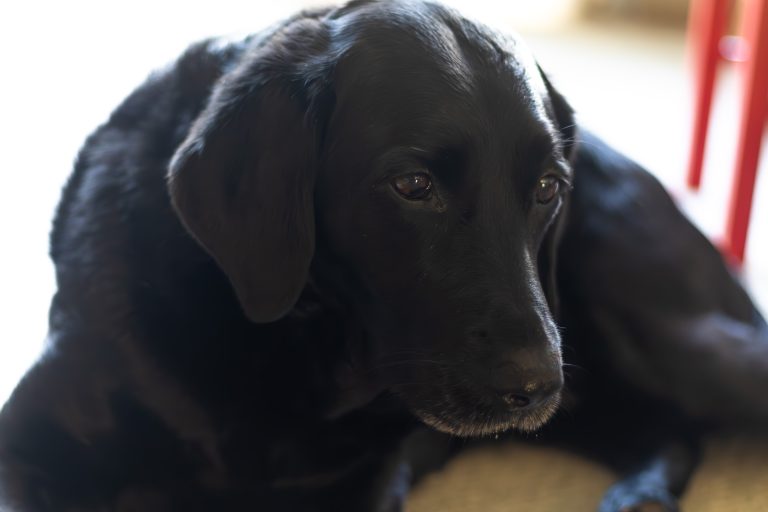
[725,0,768,263]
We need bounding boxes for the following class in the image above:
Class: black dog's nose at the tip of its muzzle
[493,366,563,409]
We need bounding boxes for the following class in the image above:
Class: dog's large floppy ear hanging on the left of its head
[168,24,328,322]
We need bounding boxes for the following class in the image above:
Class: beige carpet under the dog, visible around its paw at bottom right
[406,438,768,512]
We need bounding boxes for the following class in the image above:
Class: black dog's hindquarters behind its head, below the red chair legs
[559,132,768,427]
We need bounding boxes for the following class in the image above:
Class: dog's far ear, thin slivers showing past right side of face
[538,68,577,317]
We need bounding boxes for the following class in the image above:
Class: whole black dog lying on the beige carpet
[0,1,768,512]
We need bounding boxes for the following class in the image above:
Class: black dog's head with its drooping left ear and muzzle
[169,2,573,435]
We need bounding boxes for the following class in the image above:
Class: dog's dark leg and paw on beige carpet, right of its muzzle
[540,384,700,512]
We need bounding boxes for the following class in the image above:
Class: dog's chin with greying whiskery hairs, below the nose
[413,393,560,437]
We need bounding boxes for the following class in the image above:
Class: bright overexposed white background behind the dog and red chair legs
[0,0,768,403]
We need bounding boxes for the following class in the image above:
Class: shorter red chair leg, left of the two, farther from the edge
[687,0,731,189]
